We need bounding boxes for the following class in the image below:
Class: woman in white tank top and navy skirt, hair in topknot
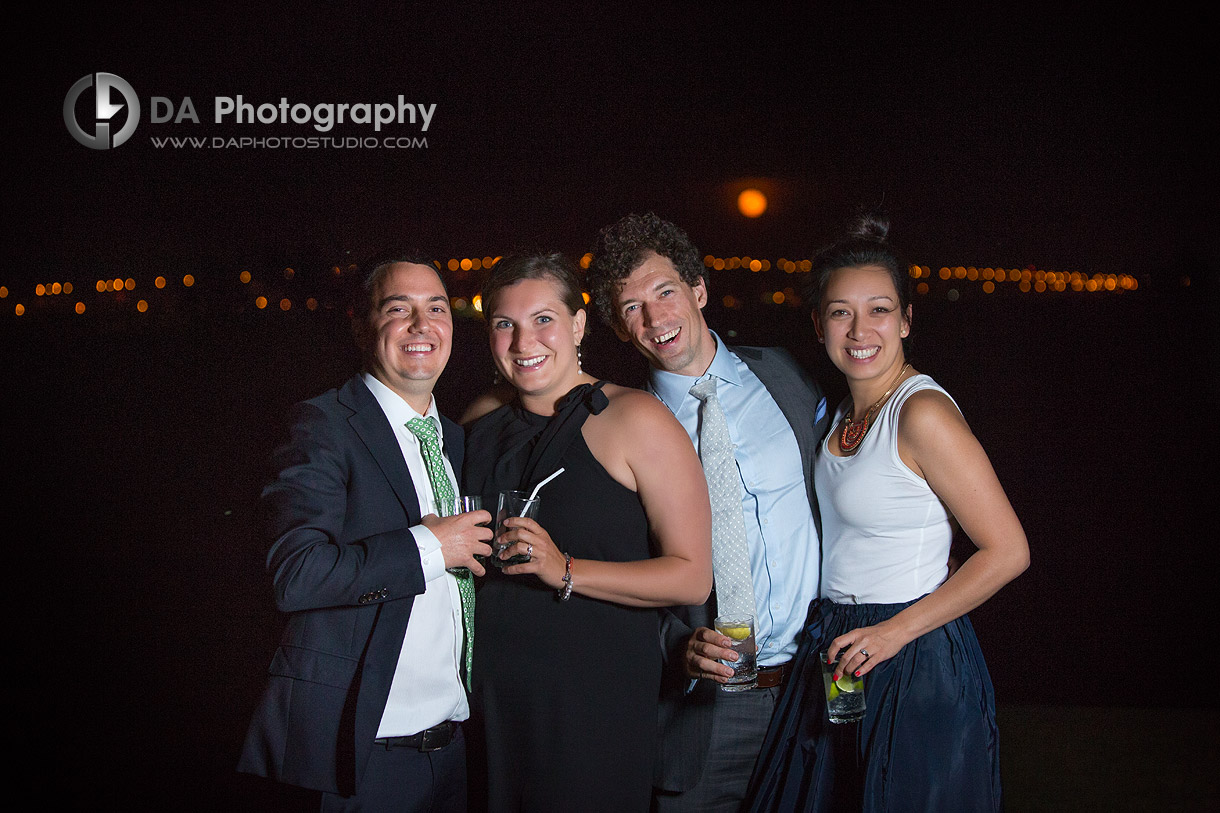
[752,216,1030,811]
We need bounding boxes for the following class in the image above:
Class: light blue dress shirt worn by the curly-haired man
[649,332,820,667]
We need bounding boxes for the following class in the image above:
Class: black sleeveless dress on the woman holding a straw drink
[464,382,661,813]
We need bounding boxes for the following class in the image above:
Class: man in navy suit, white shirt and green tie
[238,255,490,811]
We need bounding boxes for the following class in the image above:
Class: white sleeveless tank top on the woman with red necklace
[814,375,956,604]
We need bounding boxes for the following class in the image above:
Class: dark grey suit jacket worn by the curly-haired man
[653,347,828,791]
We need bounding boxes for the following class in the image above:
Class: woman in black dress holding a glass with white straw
[465,254,711,812]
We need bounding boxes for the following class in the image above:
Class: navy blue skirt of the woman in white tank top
[750,599,1000,812]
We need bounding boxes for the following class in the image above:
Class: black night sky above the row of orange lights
[6,4,1216,275]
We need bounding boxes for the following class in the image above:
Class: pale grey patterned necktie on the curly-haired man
[691,376,754,616]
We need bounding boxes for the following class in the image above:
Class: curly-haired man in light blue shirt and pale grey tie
[589,214,827,813]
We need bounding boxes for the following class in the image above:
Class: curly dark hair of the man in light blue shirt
[586,212,706,327]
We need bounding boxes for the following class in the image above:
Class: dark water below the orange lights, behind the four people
[7,283,1216,809]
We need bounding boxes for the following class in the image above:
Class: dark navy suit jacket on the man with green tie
[238,376,464,795]
